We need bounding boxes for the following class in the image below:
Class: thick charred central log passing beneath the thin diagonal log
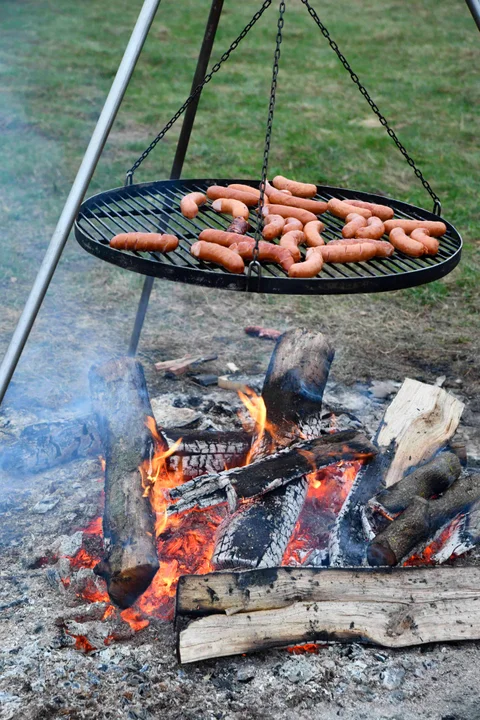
[212,330,334,570]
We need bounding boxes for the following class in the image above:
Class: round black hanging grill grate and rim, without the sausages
[75,178,463,295]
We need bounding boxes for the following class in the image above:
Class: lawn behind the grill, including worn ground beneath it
[0,0,480,404]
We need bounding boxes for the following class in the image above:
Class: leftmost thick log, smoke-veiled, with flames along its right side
[89,358,163,608]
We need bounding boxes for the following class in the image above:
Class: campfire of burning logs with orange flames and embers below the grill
[27,330,480,662]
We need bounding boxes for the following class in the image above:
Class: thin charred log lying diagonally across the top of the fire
[168,430,377,515]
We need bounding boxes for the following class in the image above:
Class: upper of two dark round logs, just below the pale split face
[369,453,462,515]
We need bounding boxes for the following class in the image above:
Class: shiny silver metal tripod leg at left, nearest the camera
[0,0,160,403]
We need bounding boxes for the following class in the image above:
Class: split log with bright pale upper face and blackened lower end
[330,378,464,567]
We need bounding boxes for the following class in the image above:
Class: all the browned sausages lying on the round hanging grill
[110,175,447,278]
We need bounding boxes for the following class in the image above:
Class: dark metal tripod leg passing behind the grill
[128,0,224,356]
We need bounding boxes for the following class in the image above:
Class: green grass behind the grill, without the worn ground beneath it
[0,0,480,400]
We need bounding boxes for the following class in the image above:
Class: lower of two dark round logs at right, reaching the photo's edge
[367,474,480,566]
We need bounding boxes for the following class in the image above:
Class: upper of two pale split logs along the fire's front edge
[175,567,480,617]
